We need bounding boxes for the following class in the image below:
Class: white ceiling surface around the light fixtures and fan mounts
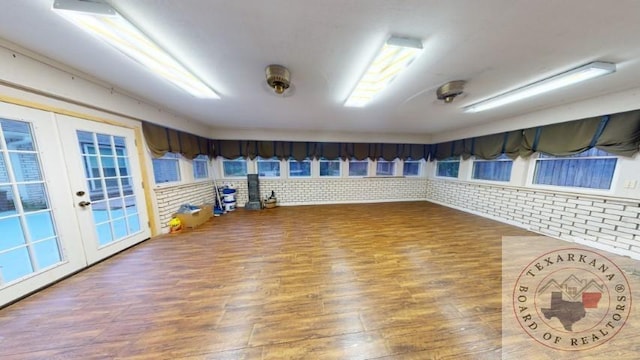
[0,0,640,138]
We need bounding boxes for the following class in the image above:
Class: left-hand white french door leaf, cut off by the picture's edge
[0,102,87,306]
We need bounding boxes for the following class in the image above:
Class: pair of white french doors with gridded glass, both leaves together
[0,103,150,306]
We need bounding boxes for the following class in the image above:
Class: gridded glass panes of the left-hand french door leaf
[0,119,64,286]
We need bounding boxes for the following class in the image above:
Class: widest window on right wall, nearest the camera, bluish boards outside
[533,148,618,189]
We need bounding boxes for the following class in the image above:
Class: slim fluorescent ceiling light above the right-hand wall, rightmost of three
[464,61,616,112]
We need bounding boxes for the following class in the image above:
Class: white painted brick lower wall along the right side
[425,179,640,259]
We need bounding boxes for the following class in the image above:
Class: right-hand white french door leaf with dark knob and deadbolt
[57,115,151,264]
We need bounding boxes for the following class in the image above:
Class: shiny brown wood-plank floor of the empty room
[0,202,636,359]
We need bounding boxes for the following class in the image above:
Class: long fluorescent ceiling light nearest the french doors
[53,0,220,99]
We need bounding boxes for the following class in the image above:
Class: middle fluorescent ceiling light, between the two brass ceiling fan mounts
[344,36,422,107]
